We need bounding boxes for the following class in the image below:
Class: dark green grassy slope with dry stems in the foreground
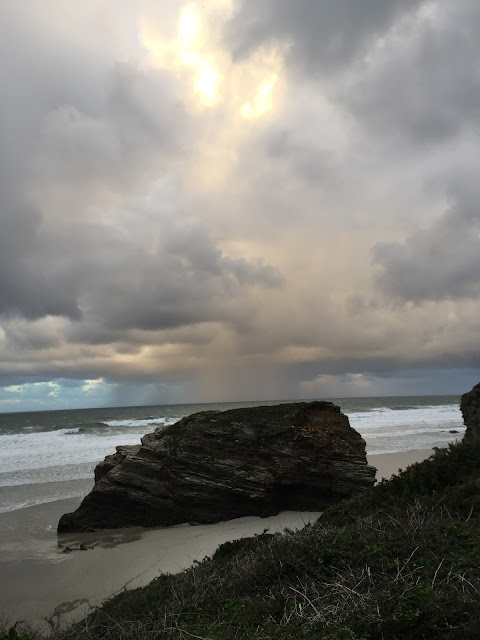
[5,442,480,640]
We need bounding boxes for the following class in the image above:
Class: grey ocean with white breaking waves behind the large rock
[0,396,465,513]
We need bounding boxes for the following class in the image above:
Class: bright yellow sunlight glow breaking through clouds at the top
[139,0,283,120]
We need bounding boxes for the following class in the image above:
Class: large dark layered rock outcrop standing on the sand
[58,402,375,532]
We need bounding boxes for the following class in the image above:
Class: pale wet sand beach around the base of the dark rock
[0,449,432,626]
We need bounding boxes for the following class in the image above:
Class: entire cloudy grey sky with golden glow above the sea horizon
[0,0,480,411]
